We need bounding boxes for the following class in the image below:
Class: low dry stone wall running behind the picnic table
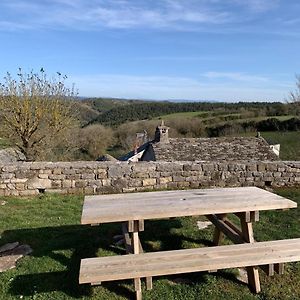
[0,161,300,196]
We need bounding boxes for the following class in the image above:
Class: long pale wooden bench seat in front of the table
[79,239,300,284]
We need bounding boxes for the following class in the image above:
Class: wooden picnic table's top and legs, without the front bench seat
[81,187,297,299]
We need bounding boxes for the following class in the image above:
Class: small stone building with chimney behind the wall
[121,122,279,161]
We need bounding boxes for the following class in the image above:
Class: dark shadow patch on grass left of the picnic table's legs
[1,224,127,298]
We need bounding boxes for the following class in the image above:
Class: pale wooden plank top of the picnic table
[81,187,297,224]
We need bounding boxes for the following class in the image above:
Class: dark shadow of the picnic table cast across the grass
[1,219,241,298]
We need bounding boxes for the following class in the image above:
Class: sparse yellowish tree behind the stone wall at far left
[0,68,76,160]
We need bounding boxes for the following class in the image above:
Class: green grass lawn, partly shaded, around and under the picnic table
[0,188,300,300]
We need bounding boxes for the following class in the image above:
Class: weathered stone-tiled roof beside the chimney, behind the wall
[152,137,279,161]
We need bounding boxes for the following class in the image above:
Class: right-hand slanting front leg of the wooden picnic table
[241,218,261,293]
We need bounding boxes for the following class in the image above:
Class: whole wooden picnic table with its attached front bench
[79,187,300,299]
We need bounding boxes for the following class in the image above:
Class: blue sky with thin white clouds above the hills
[0,0,300,102]
